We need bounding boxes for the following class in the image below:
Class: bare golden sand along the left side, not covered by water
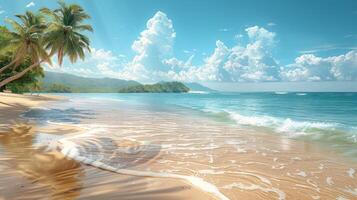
[0,93,215,200]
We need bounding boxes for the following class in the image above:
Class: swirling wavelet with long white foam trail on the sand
[48,130,228,200]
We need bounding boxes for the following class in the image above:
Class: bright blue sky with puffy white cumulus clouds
[0,0,357,91]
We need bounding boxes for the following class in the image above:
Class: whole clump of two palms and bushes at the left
[0,1,93,92]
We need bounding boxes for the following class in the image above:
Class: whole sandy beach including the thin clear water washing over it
[0,94,357,199]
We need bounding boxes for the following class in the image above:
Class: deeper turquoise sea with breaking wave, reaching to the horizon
[31,92,357,154]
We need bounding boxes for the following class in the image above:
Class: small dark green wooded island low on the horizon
[118,82,190,93]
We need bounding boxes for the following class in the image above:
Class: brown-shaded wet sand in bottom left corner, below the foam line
[0,125,211,199]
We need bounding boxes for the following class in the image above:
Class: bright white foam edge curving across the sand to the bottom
[54,132,228,200]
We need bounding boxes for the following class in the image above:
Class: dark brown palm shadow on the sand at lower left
[0,124,84,199]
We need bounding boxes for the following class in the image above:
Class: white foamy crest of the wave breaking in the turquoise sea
[229,112,337,136]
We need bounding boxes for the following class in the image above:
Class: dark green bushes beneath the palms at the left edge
[0,54,44,93]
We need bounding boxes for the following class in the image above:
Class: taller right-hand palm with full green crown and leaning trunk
[0,1,93,88]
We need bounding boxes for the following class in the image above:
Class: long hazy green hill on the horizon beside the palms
[42,71,141,93]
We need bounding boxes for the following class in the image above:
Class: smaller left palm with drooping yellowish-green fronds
[0,11,50,73]
